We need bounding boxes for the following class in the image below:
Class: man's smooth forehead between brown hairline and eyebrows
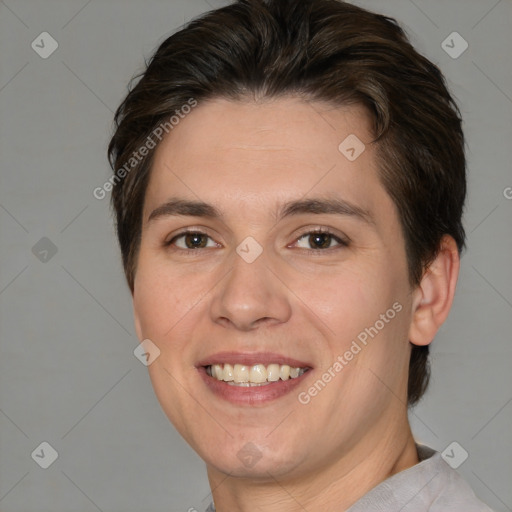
[144,97,389,223]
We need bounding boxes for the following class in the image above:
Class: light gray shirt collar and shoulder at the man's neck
[206,444,492,512]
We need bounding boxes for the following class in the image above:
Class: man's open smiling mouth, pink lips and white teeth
[197,353,312,406]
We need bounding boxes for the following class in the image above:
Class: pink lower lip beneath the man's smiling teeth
[198,366,311,405]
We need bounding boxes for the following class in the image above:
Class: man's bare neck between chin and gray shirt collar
[208,418,419,512]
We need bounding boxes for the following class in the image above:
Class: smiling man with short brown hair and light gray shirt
[109,0,489,512]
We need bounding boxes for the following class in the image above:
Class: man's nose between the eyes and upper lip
[210,251,291,331]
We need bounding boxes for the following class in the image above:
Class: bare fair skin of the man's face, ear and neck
[133,97,459,512]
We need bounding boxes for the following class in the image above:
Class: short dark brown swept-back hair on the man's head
[108,0,466,405]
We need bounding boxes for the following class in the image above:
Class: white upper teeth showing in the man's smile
[206,363,306,384]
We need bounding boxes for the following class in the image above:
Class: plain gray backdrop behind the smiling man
[0,0,512,512]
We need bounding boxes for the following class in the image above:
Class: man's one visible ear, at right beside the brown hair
[409,235,460,345]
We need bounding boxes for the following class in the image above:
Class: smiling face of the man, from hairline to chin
[133,97,412,478]
